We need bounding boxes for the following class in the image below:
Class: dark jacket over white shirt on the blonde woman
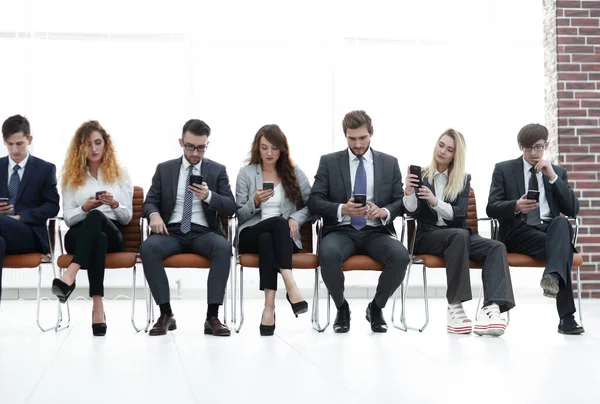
[407,174,471,234]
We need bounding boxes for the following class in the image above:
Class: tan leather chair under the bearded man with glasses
[144,215,234,332]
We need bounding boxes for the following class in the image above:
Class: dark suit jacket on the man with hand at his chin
[486,157,579,242]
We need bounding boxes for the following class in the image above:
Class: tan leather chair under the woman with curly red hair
[57,187,144,332]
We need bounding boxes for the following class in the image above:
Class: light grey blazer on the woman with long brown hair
[235,164,310,249]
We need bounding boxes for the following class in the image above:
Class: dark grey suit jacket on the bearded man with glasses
[142,157,235,236]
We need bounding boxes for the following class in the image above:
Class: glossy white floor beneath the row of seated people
[0,297,600,404]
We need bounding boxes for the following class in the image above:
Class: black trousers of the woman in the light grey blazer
[240,216,298,290]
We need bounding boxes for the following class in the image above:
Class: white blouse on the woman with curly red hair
[62,170,133,226]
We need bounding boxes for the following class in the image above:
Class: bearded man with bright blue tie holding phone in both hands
[308,111,409,333]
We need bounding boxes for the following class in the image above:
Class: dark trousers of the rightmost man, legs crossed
[506,216,575,318]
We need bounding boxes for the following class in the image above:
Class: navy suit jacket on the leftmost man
[0,154,60,253]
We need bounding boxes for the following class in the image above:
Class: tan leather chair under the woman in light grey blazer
[232,222,319,332]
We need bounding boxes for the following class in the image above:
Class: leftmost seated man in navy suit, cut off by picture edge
[0,115,60,298]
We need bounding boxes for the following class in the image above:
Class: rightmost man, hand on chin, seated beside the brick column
[486,124,584,334]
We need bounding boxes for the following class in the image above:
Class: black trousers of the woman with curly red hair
[65,209,125,297]
